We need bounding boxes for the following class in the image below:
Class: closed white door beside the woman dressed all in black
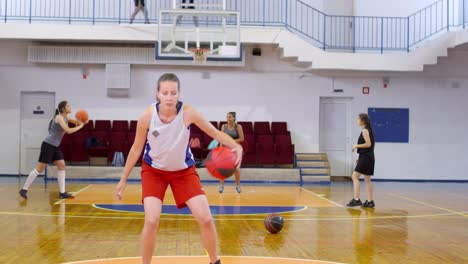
[319,98,352,176]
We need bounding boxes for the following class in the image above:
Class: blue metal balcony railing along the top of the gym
[0,0,468,53]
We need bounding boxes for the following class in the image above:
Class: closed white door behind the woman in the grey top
[20,92,56,174]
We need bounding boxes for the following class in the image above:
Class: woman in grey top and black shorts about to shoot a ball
[19,101,84,199]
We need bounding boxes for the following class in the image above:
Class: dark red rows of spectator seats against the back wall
[60,120,295,167]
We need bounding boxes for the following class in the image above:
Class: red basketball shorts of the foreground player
[141,161,205,209]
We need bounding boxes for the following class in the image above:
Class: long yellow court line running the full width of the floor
[0,212,468,221]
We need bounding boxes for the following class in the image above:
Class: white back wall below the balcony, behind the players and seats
[0,41,468,180]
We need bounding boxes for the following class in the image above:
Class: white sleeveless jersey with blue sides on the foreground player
[143,102,195,171]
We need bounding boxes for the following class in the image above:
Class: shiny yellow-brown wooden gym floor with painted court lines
[0,178,468,264]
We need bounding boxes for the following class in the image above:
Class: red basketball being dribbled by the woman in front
[205,147,237,180]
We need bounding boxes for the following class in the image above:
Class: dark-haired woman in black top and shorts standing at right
[347,114,375,208]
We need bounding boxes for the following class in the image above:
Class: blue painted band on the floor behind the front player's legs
[94,204,307,215]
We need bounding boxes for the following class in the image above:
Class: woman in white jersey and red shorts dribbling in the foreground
[116,73,242,264]
